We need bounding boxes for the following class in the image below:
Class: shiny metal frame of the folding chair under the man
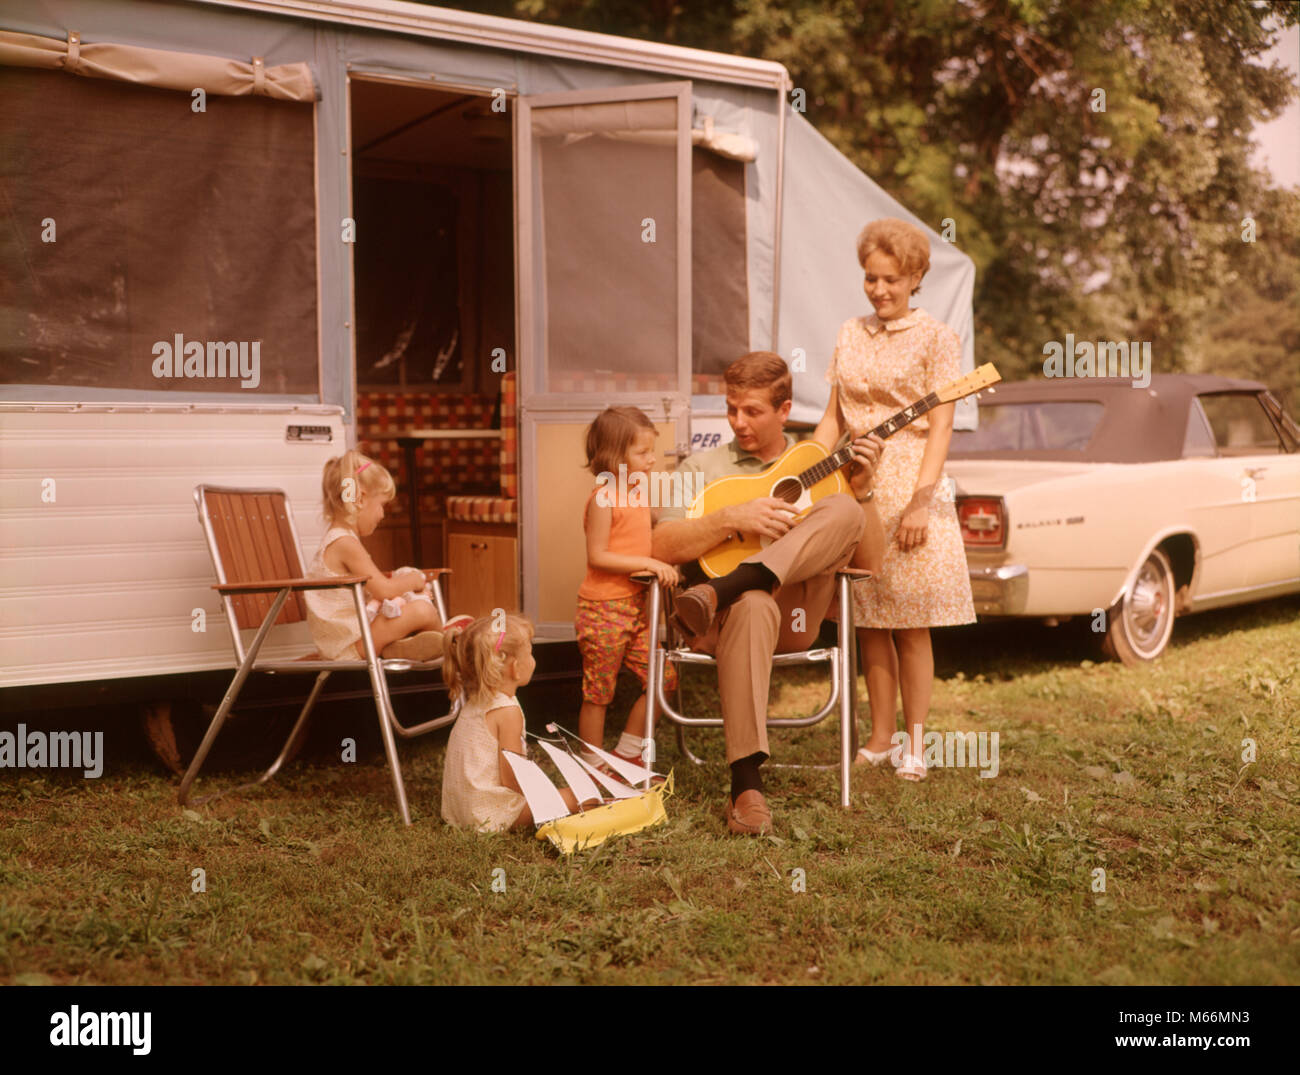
[646,568,871,810]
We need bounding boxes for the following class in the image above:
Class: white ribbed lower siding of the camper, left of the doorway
[0,404,346,686]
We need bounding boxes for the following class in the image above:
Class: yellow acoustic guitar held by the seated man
[686,363,1002,578]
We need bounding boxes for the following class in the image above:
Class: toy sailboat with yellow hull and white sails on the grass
[503,724,672,855]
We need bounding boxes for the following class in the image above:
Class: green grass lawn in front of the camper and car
[0,599,1300,984]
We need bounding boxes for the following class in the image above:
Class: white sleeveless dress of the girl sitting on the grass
[442,690,528,832]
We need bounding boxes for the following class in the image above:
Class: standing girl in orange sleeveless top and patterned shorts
[573,407,679,767]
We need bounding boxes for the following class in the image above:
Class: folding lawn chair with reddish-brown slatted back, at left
[179,485,459,824]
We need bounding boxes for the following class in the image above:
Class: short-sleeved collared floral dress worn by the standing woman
[826,309,975,629]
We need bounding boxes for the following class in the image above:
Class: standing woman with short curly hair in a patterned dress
[814,218,975,780]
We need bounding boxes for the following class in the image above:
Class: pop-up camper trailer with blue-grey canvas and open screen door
[0,0,974,717]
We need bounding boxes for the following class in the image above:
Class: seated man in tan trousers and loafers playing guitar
[653,351,885,835]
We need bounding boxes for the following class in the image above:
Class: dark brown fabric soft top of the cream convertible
[949,373,1268,463]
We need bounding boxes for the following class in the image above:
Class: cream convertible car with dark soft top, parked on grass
[946,374,1300,664]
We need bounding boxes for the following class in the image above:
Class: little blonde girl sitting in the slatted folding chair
[304,450,452,660]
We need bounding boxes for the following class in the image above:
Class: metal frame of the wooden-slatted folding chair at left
[178,485,460,825]
